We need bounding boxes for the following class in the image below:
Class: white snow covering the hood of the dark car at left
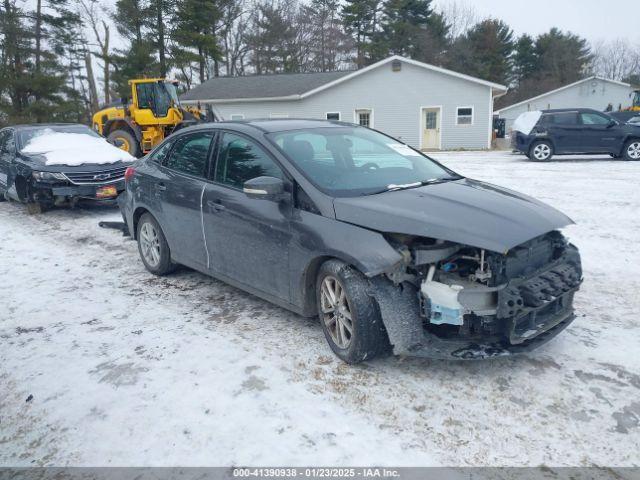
[21,129,135,166]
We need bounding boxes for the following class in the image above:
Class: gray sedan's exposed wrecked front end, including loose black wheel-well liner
[370,231,582,359]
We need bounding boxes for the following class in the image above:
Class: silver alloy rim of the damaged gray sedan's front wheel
[320,276,353,349]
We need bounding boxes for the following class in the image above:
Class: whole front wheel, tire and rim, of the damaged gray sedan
[316,260,390,364]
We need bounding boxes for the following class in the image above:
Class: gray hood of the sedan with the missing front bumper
[334,179,573,253]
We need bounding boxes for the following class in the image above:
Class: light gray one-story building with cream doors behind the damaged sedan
[181,56,507,150]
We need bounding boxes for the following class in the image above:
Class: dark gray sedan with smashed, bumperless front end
[119,120,582,363]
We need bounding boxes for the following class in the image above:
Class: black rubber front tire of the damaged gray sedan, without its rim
[316,260,390,364]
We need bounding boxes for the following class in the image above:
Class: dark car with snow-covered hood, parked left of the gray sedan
[0,124,135,211]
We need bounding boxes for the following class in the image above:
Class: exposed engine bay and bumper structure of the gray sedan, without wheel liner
[387,231,582,345]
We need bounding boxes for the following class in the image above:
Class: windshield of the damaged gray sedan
[268,126,460,197]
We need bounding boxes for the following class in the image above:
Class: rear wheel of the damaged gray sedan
[137,213,174,275]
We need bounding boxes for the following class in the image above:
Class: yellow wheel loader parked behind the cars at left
[93,78,202,157]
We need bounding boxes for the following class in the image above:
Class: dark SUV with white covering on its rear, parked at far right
[511,108,640,162]
